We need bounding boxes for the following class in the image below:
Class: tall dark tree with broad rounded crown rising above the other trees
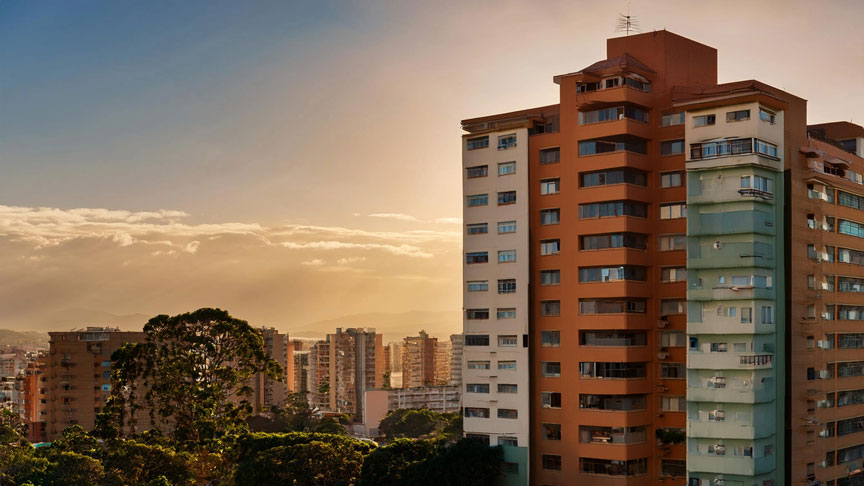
[104,308,282,444]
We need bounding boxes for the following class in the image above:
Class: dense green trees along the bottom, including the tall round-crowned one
[0,309,502,486]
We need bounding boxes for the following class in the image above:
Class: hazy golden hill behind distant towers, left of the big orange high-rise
[287,310,462,343]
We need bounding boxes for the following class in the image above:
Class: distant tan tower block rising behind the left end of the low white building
[309,328,384,420]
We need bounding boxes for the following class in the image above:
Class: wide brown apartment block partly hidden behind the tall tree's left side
[44,327,149,440]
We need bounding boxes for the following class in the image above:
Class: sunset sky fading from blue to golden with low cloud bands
[0,0,864,333]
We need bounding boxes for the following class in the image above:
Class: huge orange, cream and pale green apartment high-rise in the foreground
[462,31,864,486]
